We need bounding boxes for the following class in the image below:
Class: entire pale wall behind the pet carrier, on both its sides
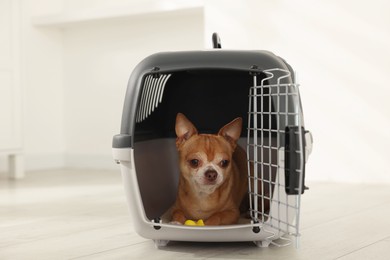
[10,0,390,182]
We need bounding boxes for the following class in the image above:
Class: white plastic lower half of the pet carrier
[113,148,300,247]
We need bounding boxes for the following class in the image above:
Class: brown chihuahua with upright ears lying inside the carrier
[171,113,248,225]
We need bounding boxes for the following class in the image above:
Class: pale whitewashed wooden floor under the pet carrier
[0,170,390,260]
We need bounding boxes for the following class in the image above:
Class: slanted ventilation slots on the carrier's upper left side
[136,74,171,123]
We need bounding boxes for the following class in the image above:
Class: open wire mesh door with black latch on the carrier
[247,69,304,246]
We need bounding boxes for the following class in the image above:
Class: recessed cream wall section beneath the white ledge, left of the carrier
[63,9,203,168]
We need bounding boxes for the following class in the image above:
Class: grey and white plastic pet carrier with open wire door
[113,34,312,246]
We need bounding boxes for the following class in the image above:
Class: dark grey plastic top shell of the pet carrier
[113,46,294,148]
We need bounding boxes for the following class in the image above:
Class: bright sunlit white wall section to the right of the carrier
[206,0,390,182]
